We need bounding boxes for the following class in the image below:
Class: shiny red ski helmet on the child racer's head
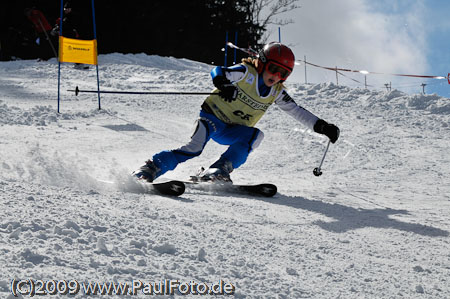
[257,42,295,82]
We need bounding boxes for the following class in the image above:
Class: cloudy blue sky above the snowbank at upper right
[268,0,450,98]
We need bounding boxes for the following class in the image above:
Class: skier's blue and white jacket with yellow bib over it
[205,62,319,130]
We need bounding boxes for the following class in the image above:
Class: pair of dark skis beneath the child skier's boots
[146,180,277,197]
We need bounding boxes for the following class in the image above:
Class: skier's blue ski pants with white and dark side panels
[152,110,264,176]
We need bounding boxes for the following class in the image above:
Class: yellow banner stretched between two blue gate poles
[59,36,97,65]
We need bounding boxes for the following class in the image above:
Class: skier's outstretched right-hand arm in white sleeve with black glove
[275,90,340,143]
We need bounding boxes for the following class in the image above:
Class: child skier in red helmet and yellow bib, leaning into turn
[133,42,339,182]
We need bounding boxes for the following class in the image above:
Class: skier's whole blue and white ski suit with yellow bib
[152,63,318,176]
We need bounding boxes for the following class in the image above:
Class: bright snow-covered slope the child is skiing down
[0,54,450,298]
